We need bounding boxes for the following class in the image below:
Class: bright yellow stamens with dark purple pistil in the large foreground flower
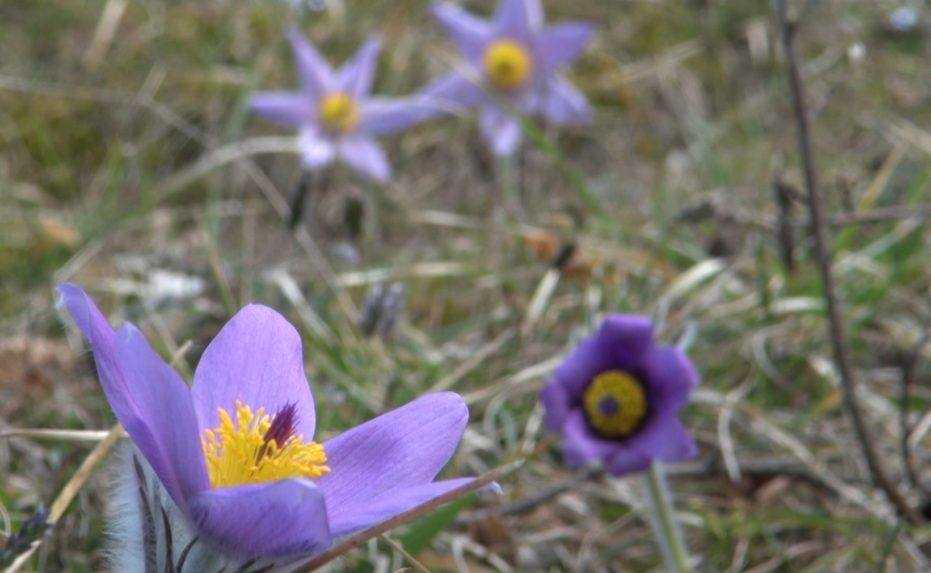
[201,401,330,488]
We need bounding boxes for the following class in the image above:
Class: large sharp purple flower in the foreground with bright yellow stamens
[59,284,469,557]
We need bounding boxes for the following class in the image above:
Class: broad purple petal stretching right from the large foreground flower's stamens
[316,392,469,523]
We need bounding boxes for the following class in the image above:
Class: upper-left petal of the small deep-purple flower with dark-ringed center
[553,314,653,400]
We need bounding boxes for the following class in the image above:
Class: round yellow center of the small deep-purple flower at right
[582,370,647,438]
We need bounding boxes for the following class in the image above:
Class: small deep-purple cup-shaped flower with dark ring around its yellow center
[540,314,698,475]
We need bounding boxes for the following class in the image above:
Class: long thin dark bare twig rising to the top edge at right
[775,0,921,522]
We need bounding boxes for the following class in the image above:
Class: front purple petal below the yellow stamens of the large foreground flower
[191,479,332,557]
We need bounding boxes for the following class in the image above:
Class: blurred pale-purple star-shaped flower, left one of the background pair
[250,30,435,183]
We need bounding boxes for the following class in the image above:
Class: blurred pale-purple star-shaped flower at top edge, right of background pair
[426,0,592,155]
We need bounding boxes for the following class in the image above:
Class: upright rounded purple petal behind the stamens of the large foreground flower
[191,304,315,440]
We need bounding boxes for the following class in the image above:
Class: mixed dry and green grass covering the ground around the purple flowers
[0,0,931,571]
